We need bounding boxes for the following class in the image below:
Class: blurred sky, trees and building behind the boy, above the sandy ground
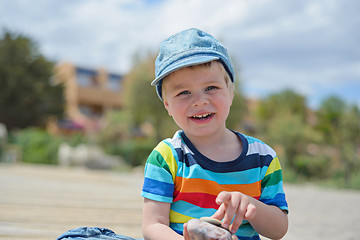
[0,0,360,189]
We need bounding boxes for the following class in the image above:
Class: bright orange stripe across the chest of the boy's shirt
[175,176,261,197]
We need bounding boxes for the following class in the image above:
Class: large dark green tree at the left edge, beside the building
[0,31,64,129]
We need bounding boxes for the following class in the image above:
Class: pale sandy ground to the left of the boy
[0,165,142,240]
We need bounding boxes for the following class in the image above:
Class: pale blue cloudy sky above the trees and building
[0,0,360,108]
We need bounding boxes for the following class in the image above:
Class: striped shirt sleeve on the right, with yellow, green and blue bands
[259,157,288,211]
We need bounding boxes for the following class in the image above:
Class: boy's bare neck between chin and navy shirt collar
[185,129,242,162]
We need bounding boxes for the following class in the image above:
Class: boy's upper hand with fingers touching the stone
[211,191,256,233]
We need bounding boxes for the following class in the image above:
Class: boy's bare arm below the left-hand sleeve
[142,198,188,240]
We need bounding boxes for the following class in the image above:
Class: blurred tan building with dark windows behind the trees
[55,63,123,130]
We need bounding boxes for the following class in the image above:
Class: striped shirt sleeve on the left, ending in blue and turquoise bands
[141,141,175,203]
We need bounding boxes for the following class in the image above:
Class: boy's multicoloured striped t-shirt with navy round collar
[141,131,288,239]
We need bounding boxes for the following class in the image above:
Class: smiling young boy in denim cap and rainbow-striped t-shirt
[142,29,288,240]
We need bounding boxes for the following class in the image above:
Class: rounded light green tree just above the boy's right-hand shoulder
[258,90,320,171]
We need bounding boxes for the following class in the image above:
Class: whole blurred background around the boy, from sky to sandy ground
[0,0,360,240]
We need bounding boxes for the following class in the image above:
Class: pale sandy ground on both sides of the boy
[0,165,360,240]
